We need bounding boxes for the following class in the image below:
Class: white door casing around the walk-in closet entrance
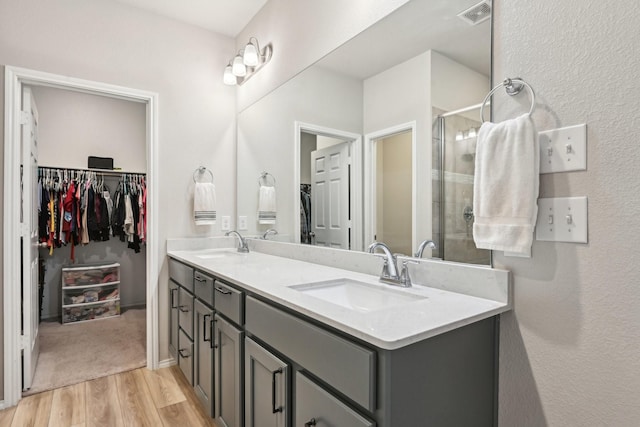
[0,66,160,408]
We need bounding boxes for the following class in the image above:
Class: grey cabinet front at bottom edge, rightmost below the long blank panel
[294,371,376,427]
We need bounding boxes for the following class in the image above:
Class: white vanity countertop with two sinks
[168,248,511,350]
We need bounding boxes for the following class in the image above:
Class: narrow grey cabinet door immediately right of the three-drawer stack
[193,300,213,417]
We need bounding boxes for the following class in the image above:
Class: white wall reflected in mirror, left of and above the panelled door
[238,67,362,236]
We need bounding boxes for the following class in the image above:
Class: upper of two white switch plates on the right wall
[538,124,587,173]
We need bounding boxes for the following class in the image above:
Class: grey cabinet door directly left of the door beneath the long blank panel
[213,314,244,427]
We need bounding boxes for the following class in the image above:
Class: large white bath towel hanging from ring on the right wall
[473,114,540,254]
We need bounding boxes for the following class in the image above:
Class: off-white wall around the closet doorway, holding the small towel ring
[0,0,236,382]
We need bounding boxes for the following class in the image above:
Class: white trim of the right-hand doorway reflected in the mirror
[364,120,418,255]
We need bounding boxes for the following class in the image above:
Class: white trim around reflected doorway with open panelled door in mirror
[291,121,363,251]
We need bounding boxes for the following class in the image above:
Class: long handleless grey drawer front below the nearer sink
[245,297,376,412]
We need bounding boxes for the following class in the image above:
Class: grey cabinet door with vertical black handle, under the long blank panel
[244,338,290,427]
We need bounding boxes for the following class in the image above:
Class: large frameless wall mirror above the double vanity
[237,0,491,264]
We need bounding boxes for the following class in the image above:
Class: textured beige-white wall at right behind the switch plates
[493,0,640,426]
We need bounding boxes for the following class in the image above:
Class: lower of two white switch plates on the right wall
[536,197,588,243]
